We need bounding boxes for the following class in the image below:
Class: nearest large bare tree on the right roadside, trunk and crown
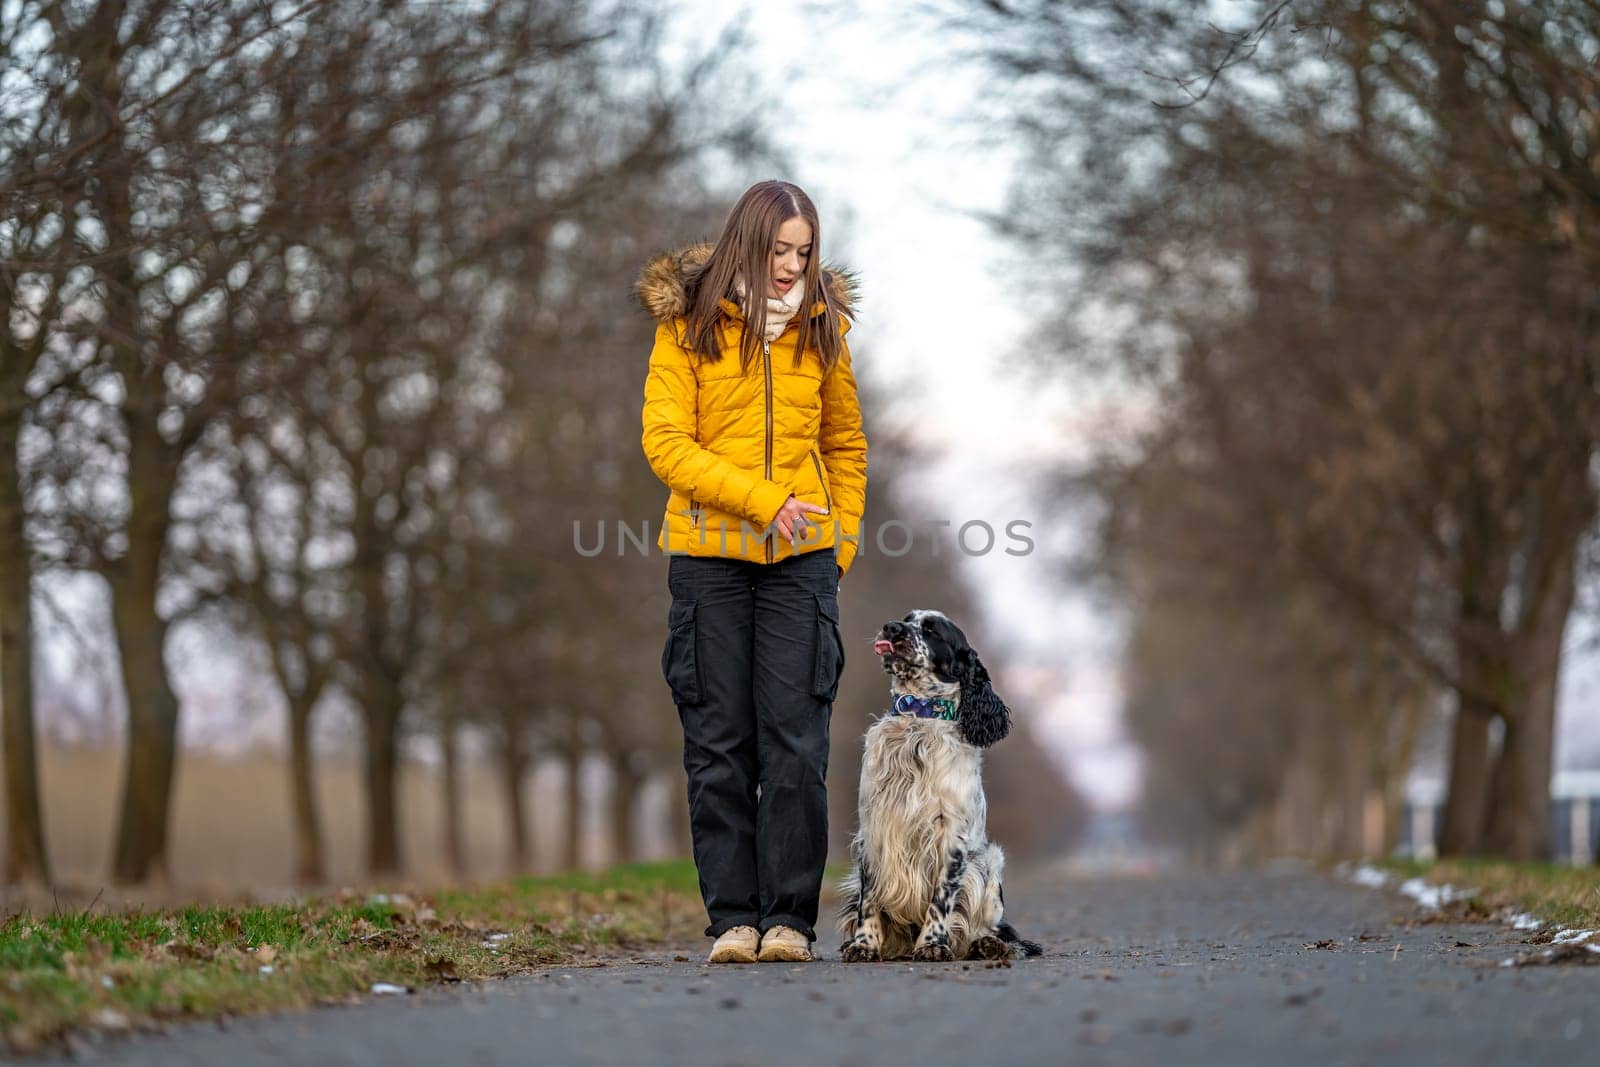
[963,0,1600,857]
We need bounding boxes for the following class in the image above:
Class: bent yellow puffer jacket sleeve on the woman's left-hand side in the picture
[642,322,790,531]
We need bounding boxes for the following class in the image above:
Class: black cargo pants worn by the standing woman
[661,547,845,941]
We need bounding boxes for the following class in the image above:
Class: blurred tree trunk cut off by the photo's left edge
[0,409,50,885]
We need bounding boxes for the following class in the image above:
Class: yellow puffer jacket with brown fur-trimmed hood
[634,245,867,571]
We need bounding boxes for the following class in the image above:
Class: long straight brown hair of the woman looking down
[686,181,843,374]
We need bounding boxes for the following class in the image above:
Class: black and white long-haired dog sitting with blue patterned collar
[838,611,1042,963]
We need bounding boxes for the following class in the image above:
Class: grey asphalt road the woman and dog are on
[37,870,1600,1067]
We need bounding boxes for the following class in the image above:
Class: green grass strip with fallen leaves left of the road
[0,862,704,1053]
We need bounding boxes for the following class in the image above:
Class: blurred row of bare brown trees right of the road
[949,0,1600,859]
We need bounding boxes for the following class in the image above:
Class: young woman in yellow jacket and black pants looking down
[637,181,867,963]
